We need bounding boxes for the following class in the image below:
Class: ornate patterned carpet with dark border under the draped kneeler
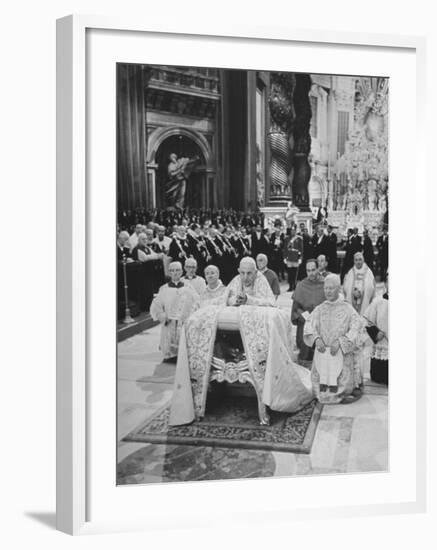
[123,395,322,453]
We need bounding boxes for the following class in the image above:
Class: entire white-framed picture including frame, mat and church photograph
[57,16,426,534]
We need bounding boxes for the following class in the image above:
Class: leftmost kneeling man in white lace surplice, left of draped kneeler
[150,262,199,359]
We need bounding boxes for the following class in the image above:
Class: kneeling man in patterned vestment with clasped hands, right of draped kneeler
[304,274,362,404]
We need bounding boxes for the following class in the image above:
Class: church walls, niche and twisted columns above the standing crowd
[117,64,389,238]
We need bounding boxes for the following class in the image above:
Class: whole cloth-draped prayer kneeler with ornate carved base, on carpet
[170,305,313,425]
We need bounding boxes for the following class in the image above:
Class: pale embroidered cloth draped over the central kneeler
[169,296,313,425]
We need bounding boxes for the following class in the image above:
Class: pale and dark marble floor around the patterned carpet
[117,286,388,484]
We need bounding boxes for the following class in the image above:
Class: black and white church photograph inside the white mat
[114,63,390,485]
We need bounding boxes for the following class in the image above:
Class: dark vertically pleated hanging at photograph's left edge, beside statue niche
[117,63,150,210]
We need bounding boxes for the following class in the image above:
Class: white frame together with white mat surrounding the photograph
[57,16,427,534]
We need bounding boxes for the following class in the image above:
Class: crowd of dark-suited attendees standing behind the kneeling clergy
[117,222,388,320]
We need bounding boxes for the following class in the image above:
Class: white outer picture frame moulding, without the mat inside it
[56,15,427,535]
